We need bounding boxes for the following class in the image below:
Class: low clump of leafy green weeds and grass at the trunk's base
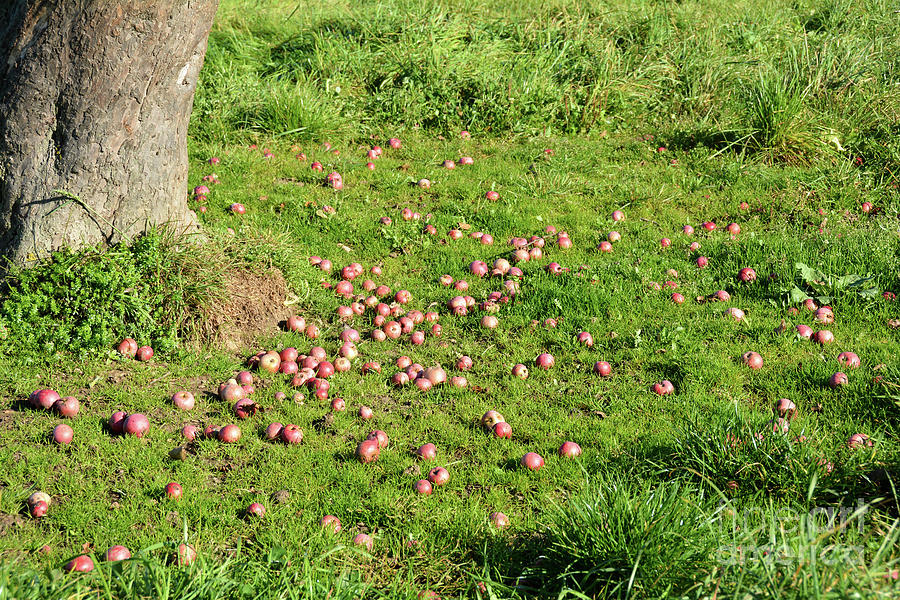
[0,227,229,357]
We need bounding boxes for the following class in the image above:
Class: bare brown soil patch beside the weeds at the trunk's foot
[204,269,291,352]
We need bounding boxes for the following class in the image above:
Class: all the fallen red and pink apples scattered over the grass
[26,132,888,571]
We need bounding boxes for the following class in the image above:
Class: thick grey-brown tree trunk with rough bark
[0,0,218,265]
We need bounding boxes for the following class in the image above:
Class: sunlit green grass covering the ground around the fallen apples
[0,0,900,599]
